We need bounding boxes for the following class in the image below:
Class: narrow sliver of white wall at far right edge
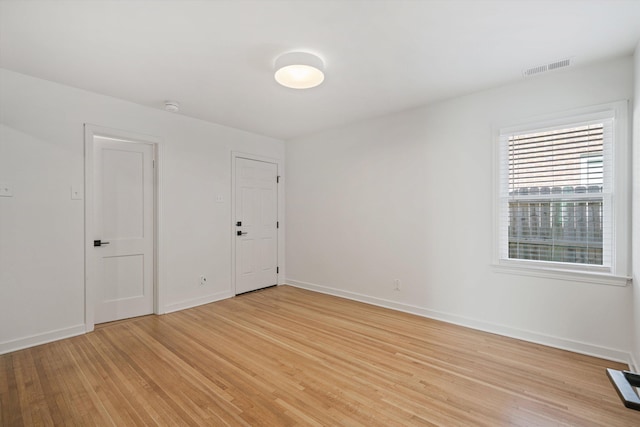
[631,42,640,372]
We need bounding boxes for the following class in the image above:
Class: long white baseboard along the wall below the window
[286,279,635,366]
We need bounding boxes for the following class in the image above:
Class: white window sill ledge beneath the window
[493,262,631,286]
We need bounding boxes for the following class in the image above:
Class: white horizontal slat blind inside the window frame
[500,119,613,266]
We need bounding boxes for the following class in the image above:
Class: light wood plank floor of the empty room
[0,286,640,426]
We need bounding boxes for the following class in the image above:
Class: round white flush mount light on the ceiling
[275,52,324,89]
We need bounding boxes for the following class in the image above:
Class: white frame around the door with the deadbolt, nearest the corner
[230,151,286,295]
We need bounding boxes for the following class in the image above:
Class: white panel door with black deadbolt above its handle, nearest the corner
[235,158,278,294]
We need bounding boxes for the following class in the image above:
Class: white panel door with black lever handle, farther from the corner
[89,136,154,323]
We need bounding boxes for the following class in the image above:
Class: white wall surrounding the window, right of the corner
[286,58,633,361]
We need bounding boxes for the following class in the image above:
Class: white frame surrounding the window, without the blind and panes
[493,101,631,286]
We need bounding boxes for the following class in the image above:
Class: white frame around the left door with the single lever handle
[84,123,163,332]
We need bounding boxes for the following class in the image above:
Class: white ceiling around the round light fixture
[0,0,640,139]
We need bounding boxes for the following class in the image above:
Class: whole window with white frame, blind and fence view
[498,102,629,284]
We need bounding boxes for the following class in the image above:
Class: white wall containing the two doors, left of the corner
[0,70,284,353]
